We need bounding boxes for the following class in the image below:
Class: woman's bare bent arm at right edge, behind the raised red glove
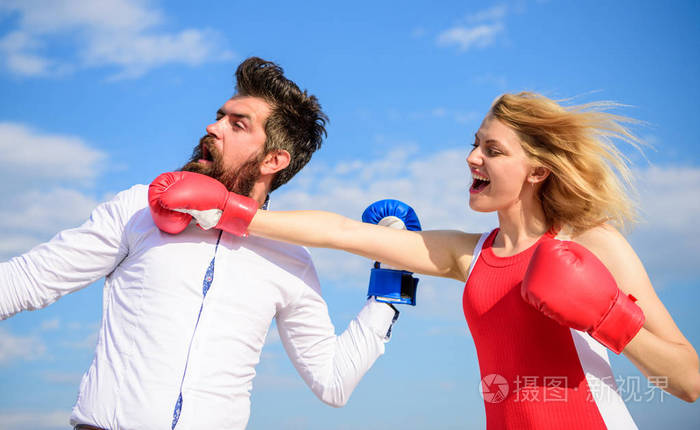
[574,226,700,402]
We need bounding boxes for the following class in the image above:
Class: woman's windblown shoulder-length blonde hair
[491,92,641,234]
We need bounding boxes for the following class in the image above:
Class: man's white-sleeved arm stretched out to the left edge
[0,187,139,319]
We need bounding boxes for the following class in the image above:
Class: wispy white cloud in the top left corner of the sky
[0,0,233,79]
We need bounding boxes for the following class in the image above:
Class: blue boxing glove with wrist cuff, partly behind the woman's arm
[362,199,421,306]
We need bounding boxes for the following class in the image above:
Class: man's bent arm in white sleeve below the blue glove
[277,267,398,407]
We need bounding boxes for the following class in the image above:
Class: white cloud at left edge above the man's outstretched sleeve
[0,122,107,259]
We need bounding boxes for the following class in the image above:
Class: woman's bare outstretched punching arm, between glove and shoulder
[248,210,479,281]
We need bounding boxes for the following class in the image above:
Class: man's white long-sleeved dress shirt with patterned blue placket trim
[0,185,395,430]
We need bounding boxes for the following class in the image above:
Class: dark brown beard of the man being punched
[180,135,264,197]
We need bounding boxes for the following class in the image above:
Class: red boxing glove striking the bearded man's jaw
[148,172,258,236]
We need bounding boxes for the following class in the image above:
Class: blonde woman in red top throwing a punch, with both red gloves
[150,93,700,429]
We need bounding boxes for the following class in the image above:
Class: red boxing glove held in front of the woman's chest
[521,240,644,354]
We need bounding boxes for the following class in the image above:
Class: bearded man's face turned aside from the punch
[181,96,271,196]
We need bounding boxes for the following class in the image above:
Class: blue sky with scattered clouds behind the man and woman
[0,0,700,429]
